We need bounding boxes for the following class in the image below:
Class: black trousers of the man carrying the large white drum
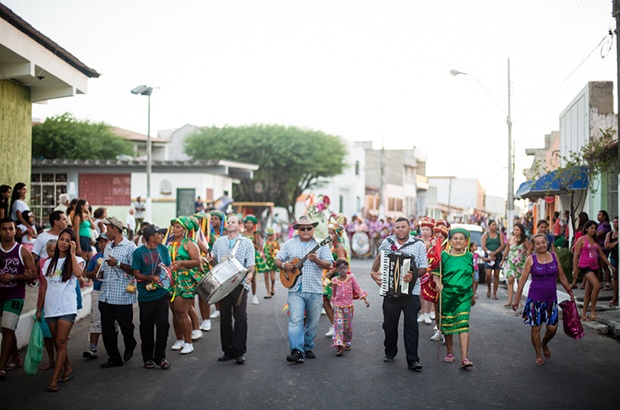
[220,285,248,357]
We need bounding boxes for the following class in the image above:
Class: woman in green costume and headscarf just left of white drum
[168,216,203,354]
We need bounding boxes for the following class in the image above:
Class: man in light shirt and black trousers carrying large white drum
[210,215,256,364]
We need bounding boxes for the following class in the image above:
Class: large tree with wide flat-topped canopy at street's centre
[185,124,346,215]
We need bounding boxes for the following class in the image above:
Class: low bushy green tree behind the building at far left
[32,113,132,159]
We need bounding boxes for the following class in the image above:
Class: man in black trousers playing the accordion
[370,217,428,371]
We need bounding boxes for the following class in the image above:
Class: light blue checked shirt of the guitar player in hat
[276,235,334,294]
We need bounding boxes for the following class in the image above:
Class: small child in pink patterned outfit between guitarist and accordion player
[332,259,370,356]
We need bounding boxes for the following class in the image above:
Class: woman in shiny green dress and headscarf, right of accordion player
[433,228,476,368]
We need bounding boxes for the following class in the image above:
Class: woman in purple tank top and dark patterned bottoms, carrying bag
[512,233,575,366]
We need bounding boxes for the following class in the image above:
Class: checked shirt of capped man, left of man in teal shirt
[99,238,138,305]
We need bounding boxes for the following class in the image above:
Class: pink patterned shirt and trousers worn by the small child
[332,272,368,348]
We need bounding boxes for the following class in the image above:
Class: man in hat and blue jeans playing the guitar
[276,215,334,363]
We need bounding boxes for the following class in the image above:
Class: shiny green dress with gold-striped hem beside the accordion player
[433,251,474,335]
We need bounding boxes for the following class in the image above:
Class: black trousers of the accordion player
[383,295,421,363]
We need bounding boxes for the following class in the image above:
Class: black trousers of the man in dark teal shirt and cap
[138,295,170,363]
